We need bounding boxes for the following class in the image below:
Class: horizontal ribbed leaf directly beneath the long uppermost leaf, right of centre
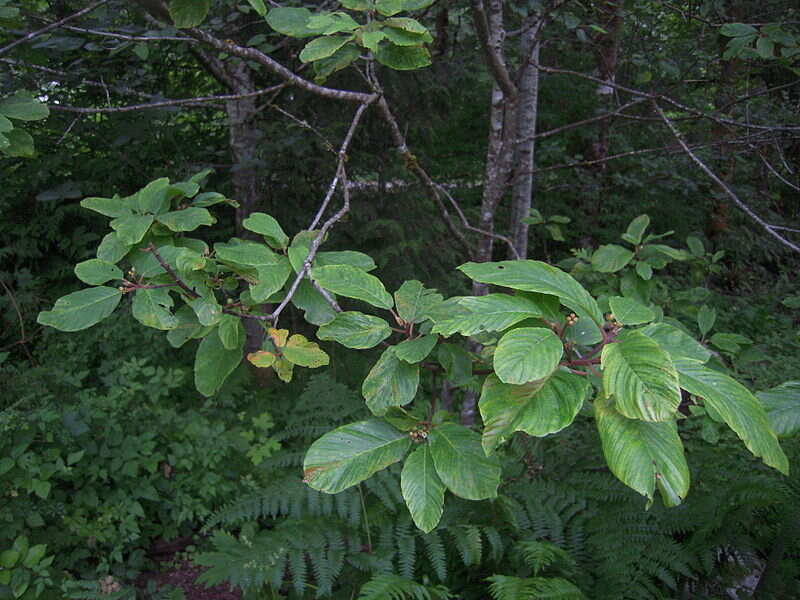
[432,294,542,336]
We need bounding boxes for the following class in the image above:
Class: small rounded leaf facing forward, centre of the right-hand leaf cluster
[494,327,564,384]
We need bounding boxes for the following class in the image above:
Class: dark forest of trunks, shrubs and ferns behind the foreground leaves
[0,0,800,599]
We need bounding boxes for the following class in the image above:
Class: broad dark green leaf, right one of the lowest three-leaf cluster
[428,423,500,500]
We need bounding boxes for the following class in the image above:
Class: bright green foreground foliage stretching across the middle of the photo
[34,173,789,532]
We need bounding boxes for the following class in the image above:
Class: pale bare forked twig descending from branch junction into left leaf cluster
[269,96,377,323]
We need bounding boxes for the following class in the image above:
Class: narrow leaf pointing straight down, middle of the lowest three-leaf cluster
[400,444,445,533]
